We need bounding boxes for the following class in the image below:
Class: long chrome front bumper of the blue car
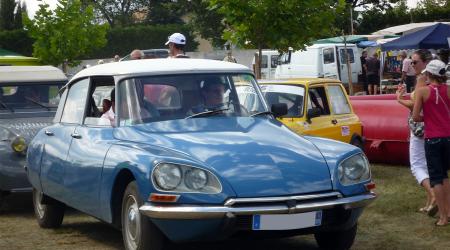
[139,192,377,219]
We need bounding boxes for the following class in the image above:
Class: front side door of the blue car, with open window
[64,77,114,217]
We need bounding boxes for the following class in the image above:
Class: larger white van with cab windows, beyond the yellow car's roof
[275,43,361,84]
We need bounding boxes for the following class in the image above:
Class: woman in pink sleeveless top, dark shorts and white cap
[413,60,450,226]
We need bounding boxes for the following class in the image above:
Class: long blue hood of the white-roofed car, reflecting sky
[115,117,332,197]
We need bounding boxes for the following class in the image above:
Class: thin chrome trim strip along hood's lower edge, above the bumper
[224,192,342,207]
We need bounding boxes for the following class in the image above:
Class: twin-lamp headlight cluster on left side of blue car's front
[152,163,222,194]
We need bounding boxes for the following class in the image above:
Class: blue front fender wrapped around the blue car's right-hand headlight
[305,136,371,196]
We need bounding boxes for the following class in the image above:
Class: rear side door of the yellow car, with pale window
[327,83,361,143]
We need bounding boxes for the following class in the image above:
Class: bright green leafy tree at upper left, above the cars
[23,0,107,66]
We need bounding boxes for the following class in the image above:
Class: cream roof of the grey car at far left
[0,66,67,84]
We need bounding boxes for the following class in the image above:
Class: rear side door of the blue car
[41,79,89,202]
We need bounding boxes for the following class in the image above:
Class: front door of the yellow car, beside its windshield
[303,84,339,140]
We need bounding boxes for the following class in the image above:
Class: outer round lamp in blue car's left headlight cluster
[154,164,182,190]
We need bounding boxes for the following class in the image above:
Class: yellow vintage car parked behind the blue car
[251,78,364,148]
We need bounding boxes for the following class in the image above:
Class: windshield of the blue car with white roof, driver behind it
[118,74,267,126]
